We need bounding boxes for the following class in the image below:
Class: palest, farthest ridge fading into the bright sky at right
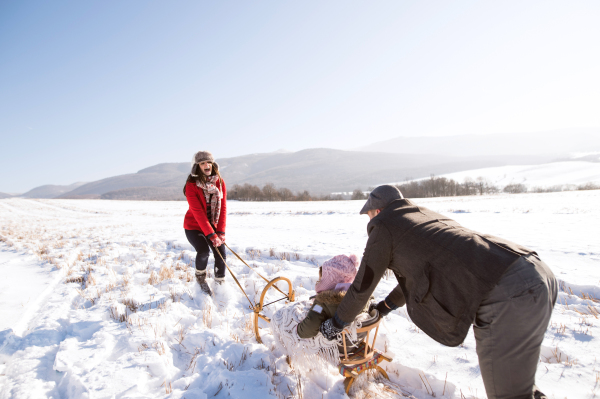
[357,128,600,161]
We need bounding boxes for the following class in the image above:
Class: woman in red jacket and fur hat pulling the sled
[183,151,227,295]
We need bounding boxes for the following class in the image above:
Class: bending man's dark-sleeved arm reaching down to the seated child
[334,220,396,325]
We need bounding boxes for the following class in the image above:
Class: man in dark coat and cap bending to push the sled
[320,185,557,399]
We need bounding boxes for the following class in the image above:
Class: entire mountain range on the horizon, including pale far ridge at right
[9,129,600,200]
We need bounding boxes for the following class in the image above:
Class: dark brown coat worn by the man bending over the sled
[337,199,535,346]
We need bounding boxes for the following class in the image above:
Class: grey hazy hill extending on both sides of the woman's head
[50,148,545,200]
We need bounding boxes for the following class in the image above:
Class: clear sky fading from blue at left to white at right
[0,0,600,193]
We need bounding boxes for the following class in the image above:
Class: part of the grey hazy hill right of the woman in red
[218,148,552,194]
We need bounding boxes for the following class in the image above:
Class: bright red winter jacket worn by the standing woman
[183,179,227,238]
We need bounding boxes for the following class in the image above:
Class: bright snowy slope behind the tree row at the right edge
[400,161,600,188]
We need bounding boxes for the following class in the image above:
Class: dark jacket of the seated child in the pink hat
[298,290,370,338]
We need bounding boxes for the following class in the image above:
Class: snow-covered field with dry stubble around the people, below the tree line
[0,191,600,399]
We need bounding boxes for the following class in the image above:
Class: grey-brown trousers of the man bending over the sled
[473,254,558,399]
